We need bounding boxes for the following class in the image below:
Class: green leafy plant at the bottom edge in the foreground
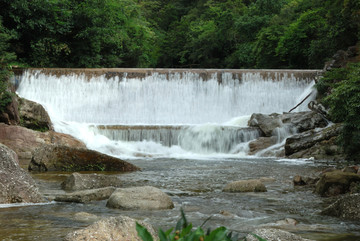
[136,209,266,241]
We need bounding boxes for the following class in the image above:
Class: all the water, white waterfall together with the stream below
[4,69,360,240]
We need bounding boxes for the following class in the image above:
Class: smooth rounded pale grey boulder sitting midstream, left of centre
[106,186,174,210]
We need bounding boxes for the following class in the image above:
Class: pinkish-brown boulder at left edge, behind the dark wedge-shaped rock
[0,123,85,168]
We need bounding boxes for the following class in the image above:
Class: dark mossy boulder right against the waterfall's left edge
[19,98,53,131]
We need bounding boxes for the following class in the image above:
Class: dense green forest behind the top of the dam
[0,0,360,69]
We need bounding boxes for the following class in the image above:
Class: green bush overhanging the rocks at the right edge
[317,63,360,161]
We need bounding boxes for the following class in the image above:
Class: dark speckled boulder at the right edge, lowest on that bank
[321,193,360,221]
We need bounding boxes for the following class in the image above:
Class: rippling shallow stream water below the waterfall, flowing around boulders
[0,158,360,240]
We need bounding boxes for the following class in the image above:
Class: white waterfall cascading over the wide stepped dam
[17,69,316,158]
